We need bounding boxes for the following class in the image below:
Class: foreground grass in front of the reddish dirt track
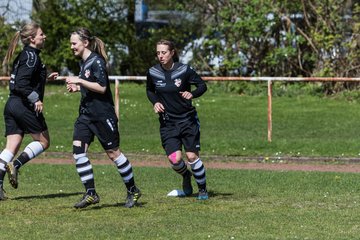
[0,164,360,239]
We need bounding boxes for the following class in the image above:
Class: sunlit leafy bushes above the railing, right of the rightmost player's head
[179,0,360,77]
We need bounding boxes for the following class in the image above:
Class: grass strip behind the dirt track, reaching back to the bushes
[0,83,360,157]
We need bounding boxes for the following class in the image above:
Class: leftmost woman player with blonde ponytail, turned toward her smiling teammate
[0,23,58,200]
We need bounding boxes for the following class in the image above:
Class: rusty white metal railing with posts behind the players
[0,76,360,142]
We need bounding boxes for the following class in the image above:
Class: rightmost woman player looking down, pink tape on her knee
[146,40,209,200]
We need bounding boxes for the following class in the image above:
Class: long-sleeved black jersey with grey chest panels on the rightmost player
[146,62,207,121]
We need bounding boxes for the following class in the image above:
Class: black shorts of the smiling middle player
[73,114,120,150]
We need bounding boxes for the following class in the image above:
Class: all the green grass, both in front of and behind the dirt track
[0,83,360,240]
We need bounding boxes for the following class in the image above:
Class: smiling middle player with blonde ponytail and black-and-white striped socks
[66,28,141,208]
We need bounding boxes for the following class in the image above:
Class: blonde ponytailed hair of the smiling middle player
[71,28,108,62]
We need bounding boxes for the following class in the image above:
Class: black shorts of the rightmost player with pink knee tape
[160,116,200,156]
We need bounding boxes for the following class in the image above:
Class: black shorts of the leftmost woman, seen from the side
[4,97,48,136]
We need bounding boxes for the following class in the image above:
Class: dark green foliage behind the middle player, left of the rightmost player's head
[33,0,198,75]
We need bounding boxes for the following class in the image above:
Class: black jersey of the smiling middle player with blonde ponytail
[79,52,115,119]
